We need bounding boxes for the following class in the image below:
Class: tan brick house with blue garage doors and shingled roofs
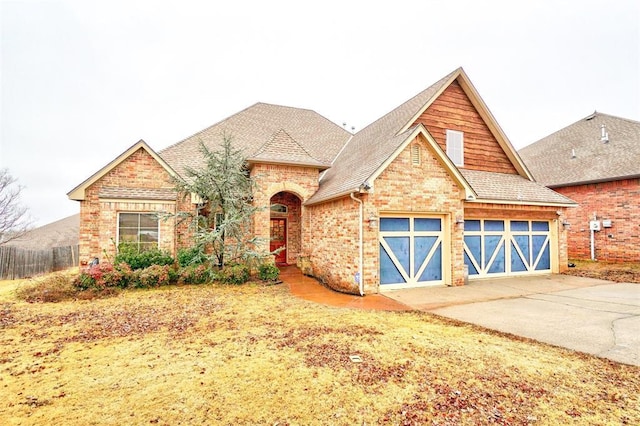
[68,68,574,294]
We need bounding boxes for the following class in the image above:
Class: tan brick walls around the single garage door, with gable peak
[303,138,464,294]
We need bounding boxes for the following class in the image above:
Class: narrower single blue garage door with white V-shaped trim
[379,217,443,289]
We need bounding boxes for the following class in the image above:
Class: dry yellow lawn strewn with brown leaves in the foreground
[0,274,640,425]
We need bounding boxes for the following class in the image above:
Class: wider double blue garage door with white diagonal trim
[464,219,551,277]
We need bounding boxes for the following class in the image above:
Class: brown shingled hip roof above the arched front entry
[159,103,351,174]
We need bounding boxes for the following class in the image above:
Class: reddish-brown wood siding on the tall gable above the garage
[414,81,518,174]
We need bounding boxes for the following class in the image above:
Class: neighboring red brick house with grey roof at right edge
[520,112,640,262]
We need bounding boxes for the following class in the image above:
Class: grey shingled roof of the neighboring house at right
[519,112,640,187]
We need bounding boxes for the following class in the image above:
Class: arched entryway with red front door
[269,191,302,265]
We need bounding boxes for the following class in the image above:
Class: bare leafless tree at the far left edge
[0,169,31,246]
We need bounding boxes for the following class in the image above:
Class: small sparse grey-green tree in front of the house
[176,135,259,268]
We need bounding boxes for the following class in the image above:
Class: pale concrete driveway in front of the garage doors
[384,275,640,366]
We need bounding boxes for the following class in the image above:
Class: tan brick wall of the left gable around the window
[79,148,191,265]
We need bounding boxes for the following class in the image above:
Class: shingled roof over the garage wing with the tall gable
[307,68,575,205]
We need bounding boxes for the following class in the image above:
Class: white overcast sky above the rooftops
[0,0,640,225]
